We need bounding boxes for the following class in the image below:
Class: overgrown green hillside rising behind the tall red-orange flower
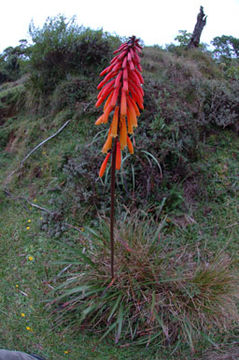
[0,19,239,360]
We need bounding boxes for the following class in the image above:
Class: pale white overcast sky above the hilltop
[0,0,239,52]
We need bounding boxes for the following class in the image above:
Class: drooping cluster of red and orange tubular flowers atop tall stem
[95,36,144,177]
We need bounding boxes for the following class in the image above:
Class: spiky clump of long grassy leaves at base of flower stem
[52,220,239,349]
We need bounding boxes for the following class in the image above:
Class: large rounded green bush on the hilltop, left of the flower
[29,15,120,94]
